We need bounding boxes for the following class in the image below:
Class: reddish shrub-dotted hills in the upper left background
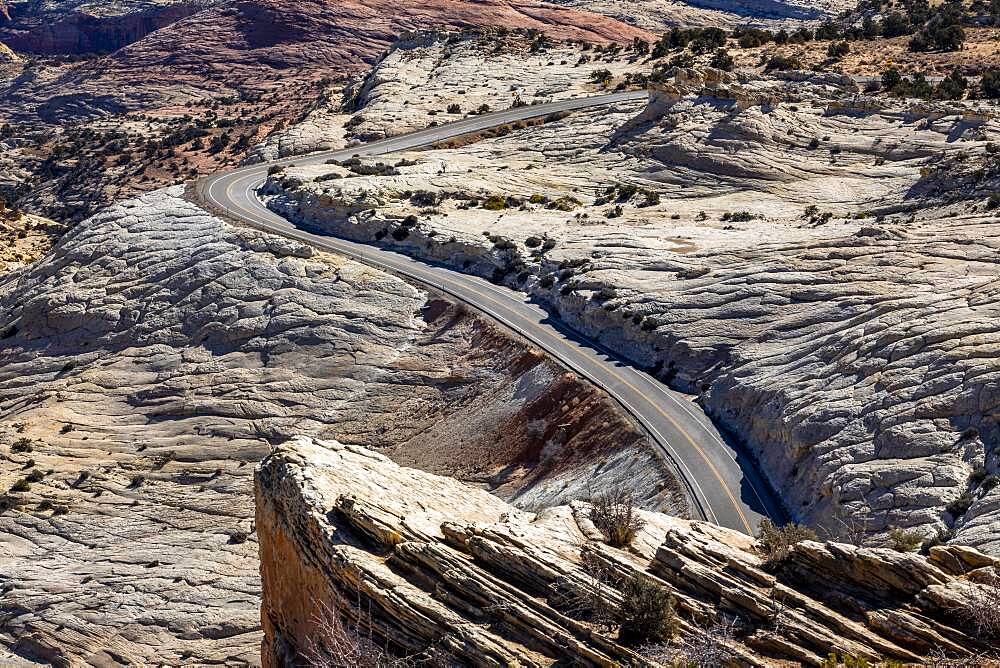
[0,0,651,222]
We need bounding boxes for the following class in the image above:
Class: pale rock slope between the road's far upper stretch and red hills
[248,31,653,162]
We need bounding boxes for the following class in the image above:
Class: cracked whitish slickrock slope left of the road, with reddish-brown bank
[0,189,684,665]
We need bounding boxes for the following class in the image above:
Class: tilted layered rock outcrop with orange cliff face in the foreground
[255,438,1000,666]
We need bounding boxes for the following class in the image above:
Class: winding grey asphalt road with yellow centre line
[196,91,784,533]
